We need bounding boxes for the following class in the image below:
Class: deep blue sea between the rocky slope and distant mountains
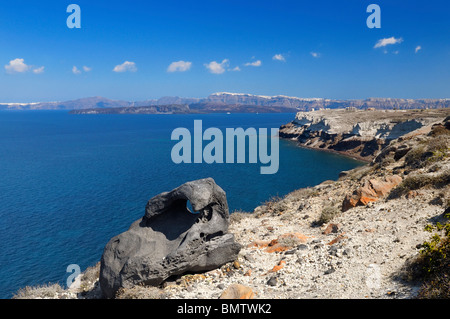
[0,111,361,298]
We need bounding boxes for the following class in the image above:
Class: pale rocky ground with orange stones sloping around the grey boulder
[12,112,450,299]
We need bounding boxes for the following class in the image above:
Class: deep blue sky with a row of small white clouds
[0,0,450,102]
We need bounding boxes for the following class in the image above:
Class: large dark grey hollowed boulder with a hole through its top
[100,178,241,298]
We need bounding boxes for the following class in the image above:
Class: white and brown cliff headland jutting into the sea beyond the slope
[280,109,450,161]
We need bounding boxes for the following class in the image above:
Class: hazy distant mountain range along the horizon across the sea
[0,92,450,113]
